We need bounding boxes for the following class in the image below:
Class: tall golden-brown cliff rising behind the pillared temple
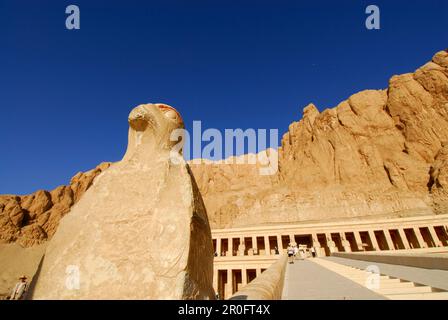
[192,51,448,228]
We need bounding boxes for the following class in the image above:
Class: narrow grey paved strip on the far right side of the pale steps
[323,257,448,290]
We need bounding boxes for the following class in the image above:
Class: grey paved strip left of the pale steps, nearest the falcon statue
[283,258,385,300]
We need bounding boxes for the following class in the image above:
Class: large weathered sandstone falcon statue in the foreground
[33,104,214,299]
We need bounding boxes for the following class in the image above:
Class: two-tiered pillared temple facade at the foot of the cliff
[212,215,448,299]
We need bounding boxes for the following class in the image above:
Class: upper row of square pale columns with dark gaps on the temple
[213,225,448,257]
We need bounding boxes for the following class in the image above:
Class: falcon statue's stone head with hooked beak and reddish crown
[123,103,184,160]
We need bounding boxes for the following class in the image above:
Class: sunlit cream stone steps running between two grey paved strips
[310,258,448,300]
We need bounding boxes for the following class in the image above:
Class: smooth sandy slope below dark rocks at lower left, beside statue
[0,244,46,300]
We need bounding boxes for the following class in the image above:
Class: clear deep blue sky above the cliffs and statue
[0,0,448,194]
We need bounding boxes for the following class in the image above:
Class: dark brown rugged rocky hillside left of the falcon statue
[0,162,110,247]
